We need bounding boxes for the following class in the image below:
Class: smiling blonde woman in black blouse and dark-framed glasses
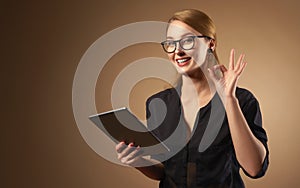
[116,9,269,188]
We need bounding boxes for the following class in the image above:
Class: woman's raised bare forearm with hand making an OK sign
[209,50,266,177]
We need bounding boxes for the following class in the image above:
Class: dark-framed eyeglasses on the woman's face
[160,36,211,53]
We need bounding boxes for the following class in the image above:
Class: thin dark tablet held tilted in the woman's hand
[89,107,169,155]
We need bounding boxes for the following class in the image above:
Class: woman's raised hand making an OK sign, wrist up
[208,49,247,105]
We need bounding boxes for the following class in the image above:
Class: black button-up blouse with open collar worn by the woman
[146,88,269,188]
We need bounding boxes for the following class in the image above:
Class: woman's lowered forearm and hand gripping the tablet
[116,142,164,180]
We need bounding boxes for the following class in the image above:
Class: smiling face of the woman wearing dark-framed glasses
[162,20,215,74]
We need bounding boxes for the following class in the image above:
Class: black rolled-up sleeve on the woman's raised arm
[242,96,269,179]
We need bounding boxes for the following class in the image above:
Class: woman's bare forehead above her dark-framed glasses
[167,20,201,39]
